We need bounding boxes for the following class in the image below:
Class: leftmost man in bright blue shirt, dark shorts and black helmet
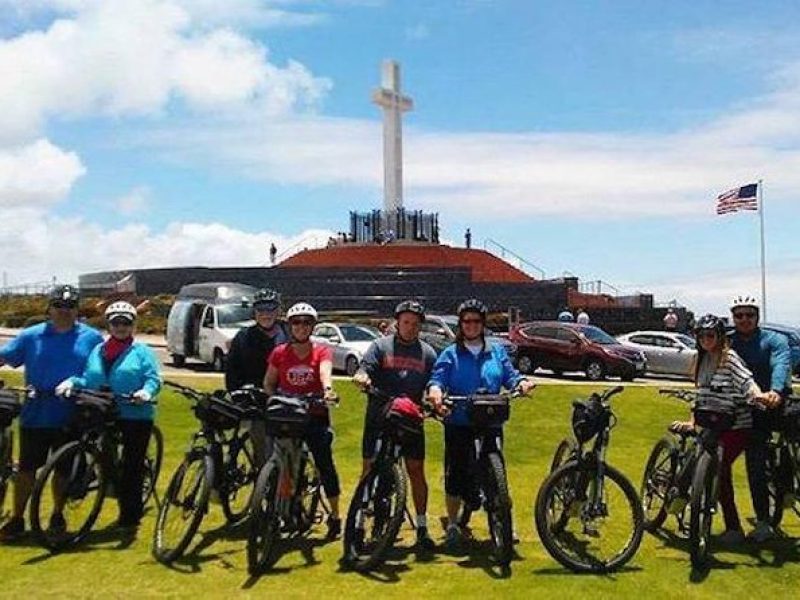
[0,285,103,541]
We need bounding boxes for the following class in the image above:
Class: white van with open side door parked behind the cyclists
[167,282,257,371]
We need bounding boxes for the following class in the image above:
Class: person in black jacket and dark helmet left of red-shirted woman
[225,289,289,467]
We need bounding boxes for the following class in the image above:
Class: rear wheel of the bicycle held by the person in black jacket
[219,432,258,524]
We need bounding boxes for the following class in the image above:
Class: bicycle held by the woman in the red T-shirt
[247,394,338,576]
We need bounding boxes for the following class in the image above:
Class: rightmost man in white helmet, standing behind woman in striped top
[730,296,792,542]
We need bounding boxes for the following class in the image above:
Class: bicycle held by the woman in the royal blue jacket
[446,390,522,569]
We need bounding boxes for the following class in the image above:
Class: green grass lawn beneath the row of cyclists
[0,374,800,599]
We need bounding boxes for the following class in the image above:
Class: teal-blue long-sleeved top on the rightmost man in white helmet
[730,329,792,393]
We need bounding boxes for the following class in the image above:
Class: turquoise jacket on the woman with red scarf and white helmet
[71,342,161,421]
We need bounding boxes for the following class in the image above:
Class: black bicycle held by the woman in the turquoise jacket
[30,390,164,552]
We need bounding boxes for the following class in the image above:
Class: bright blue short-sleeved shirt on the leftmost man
[0,322,103,428]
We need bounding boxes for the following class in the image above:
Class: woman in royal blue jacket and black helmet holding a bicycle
[428,299,533,547]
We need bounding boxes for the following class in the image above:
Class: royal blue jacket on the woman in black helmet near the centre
[429,342,523,426]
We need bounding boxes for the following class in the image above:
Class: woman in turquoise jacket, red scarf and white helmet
[56,302,161,530]
